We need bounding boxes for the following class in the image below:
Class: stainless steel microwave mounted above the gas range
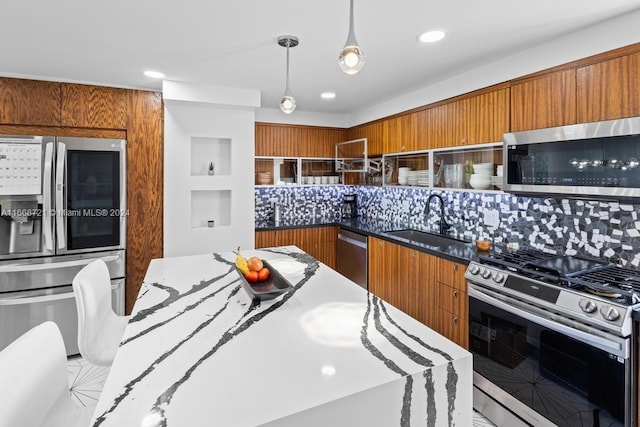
[503,117,640,198]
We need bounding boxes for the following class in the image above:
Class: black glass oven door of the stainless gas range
[469,283,635,426]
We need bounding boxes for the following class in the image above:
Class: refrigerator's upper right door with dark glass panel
[56,137,127,254]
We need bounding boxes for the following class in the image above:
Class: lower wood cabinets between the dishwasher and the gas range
[368,237,469,348]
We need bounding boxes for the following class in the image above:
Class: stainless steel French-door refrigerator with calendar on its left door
[0,136,127,354]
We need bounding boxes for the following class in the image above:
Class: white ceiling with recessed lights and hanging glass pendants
[0,0,640,114]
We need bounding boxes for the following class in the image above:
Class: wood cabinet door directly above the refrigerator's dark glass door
[61,83,128,129]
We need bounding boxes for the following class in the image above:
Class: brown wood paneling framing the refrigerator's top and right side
[0,78,164,313]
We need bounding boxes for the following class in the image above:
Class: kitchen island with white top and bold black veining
[93,246,472,427]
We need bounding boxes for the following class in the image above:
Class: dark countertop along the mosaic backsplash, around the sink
[255,217,496,264]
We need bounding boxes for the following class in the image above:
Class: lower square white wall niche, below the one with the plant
[191,190,231,229]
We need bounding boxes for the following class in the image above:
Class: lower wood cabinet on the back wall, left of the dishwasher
[255,226,338,270]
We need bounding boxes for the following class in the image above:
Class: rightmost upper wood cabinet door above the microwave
[577,53,640,123]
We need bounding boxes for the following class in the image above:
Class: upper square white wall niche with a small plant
[191,137,231,176]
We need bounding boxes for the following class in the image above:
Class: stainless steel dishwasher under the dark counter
[338,229,368,289]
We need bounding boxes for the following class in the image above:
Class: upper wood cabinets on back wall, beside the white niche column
[255,123,347,157]
